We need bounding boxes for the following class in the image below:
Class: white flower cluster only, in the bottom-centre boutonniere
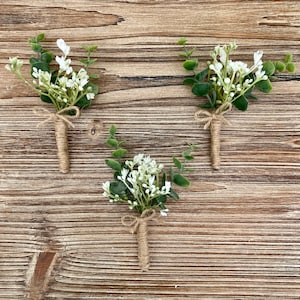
[102,154,171,216]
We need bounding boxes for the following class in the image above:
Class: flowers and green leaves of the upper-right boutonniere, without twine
[178,38,295,111]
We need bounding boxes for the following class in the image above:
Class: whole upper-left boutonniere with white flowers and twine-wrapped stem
[5,34,98,173]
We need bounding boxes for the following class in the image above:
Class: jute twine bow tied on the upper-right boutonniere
[194,102,232,129]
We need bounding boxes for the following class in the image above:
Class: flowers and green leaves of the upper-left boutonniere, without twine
[5,33,99,111]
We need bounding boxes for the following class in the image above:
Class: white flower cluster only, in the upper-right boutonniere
[209,43,268,102]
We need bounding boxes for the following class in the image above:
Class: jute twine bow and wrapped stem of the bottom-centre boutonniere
[121,209,156,271]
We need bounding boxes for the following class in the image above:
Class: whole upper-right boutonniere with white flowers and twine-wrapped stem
[178,38,295,169]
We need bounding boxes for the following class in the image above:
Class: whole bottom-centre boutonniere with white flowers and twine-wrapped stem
[102,126,196,271]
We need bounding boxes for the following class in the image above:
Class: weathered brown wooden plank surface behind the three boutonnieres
[0,0,300,300]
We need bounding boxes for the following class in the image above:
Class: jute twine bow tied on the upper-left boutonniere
[33,106,80,128]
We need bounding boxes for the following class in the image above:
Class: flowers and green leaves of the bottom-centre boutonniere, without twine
[102,125,197,215]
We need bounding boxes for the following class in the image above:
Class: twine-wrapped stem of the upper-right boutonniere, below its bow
[210,118,222,170]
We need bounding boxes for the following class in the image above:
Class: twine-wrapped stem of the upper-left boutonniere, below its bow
[54,118,70,173]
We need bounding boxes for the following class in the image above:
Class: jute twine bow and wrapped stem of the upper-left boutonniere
[33,106,80,173]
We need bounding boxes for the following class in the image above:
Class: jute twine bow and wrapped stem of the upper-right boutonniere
[195,102,232,170]
